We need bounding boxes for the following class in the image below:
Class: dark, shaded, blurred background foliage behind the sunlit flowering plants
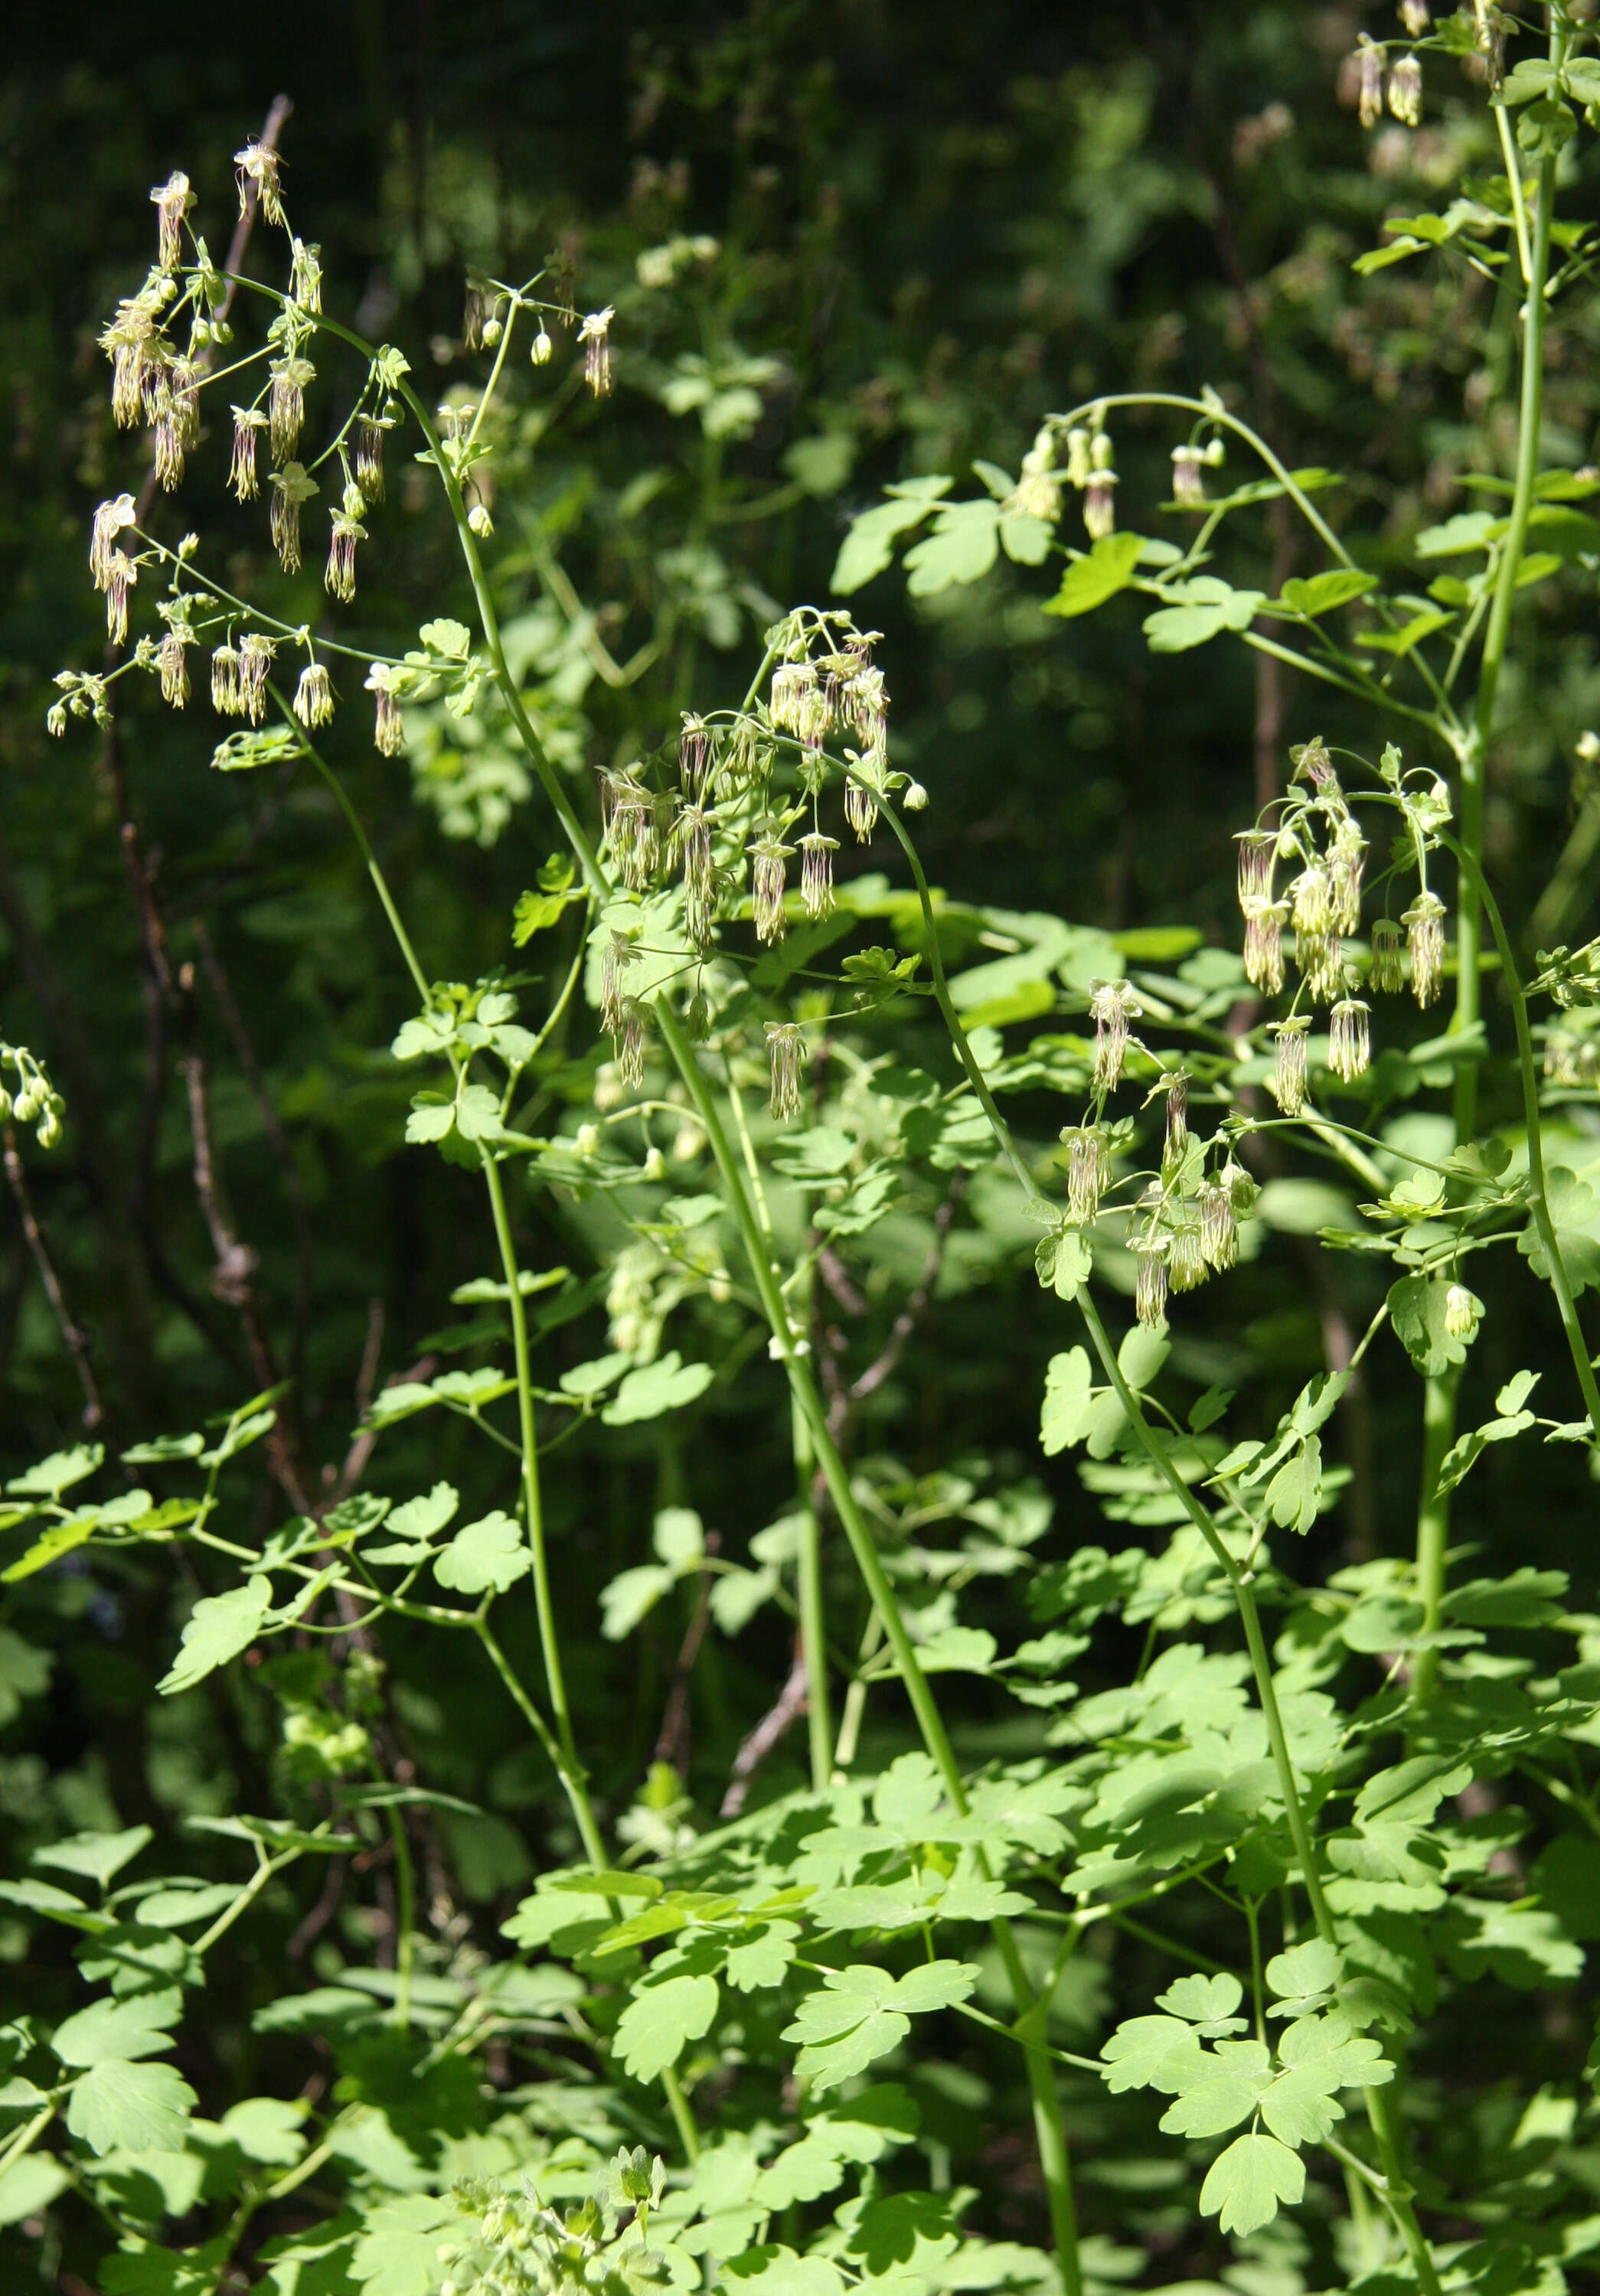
[0,0,1600,2296]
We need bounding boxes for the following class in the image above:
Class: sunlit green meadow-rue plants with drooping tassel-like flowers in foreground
[15,13,1600,2296]
